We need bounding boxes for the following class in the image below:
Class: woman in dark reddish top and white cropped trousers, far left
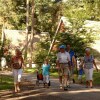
[11,49,24,92]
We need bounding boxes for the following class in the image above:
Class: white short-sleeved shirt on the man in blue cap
[57,52,70,63]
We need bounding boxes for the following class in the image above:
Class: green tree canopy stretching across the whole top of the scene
[0,0,100,63]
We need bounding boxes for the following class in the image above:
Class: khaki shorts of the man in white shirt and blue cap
[58,64,70,76]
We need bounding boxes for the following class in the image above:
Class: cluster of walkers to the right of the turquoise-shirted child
[57,44,98,90]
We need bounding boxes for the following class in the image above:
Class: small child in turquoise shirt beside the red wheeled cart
[42,59,50,87]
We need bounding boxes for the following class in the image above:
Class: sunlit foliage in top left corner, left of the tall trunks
[0,0,26,29]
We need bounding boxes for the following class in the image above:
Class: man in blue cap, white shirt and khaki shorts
[57,45,70,90]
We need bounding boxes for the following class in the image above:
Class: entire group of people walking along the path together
[11,44,98,92]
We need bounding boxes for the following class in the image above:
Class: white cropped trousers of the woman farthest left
[13,69,22,83]
